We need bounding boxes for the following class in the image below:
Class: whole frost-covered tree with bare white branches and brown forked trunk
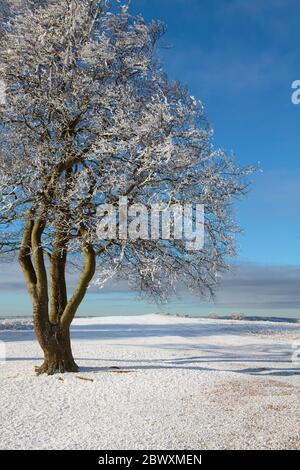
[0,0,252,374]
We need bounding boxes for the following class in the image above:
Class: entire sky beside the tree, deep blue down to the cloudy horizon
[0,0,300,318]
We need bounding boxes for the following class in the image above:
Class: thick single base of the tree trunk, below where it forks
[35,318,78,375]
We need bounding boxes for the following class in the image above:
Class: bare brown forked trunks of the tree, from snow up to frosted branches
[19,213,96,375]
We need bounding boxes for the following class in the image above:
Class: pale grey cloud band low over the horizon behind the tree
[0,261,300,319]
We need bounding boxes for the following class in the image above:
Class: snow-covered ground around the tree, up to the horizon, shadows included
[0,315,300,450]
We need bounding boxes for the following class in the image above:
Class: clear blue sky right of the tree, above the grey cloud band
[133,0,300,265]
